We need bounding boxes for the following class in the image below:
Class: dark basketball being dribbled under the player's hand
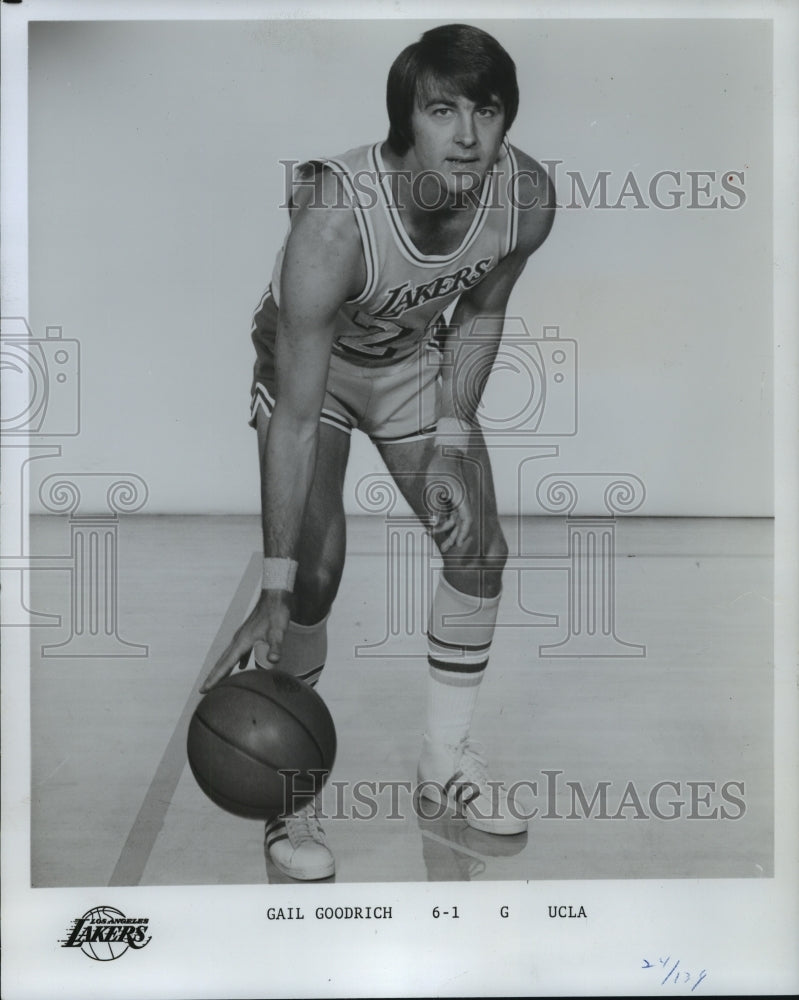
[187,670,336,819]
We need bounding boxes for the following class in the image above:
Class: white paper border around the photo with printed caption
[2,0,799,1000]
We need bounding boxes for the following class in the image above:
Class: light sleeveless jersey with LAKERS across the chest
[264,142,518,367]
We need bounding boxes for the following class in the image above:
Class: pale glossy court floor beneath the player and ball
[31,516,773,886]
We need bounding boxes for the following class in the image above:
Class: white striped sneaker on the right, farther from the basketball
[417,736,527,836]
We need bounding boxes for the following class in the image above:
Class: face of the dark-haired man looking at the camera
[408,89,505,199]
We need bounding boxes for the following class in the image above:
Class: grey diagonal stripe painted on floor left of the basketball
[108,552,261,885]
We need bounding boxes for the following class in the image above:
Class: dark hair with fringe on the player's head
[386,24,519,156]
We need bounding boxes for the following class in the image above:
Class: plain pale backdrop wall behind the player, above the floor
[29,20,772,516]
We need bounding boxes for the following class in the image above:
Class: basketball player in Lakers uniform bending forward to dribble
[202,24,554,879]
